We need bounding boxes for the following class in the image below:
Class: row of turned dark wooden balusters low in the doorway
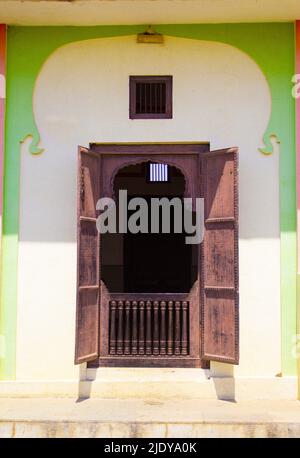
[109,301,189,357]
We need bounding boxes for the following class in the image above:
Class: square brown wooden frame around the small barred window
[129,75,173,119]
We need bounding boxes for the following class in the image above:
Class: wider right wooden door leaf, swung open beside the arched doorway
[201,148,239,364]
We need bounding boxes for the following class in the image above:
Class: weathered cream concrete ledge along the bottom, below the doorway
[0,398,300,438]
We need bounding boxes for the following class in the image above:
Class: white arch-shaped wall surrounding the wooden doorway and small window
[17,36,281,380]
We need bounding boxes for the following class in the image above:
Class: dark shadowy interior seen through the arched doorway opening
[101,162,198,293]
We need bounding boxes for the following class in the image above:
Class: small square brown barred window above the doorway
[129,76,173,119]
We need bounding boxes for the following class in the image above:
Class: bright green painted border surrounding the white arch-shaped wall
[0,23,296,379]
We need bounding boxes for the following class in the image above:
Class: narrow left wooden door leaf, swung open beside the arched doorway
[75,147,100,364]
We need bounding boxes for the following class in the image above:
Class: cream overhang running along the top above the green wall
[0,0,300,25]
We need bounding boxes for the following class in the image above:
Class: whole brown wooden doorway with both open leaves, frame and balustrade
[75,144,238,367]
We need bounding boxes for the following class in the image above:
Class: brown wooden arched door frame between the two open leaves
[88,142,210,368]
